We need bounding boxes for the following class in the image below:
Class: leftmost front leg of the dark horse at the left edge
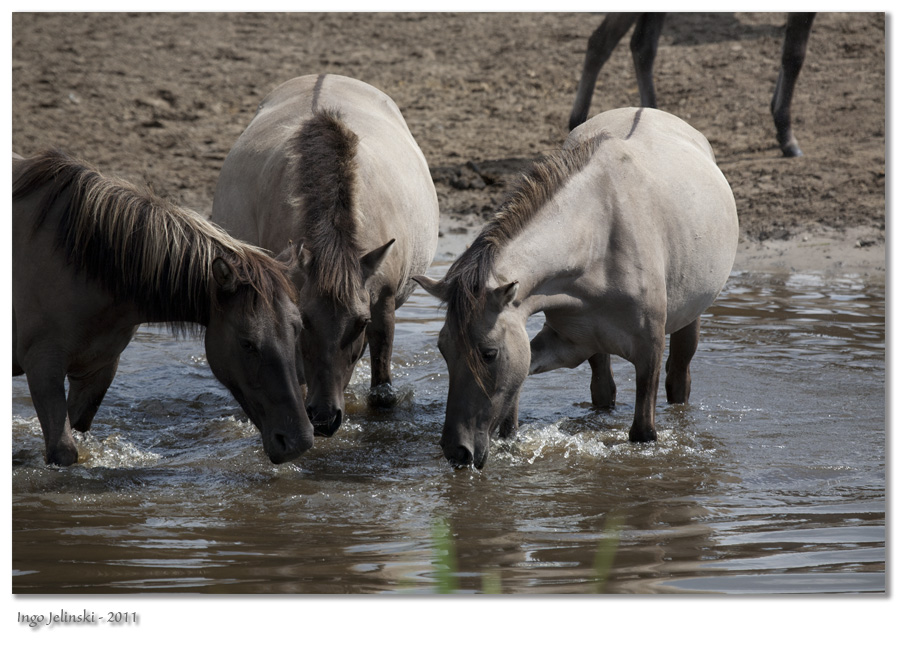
[25,360,78,467]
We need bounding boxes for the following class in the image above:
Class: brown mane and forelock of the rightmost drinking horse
[441,132,609,385]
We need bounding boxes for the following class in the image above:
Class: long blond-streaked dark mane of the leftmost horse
[13,150,295,332]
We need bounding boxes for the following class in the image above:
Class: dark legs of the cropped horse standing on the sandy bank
[569,13,816,157]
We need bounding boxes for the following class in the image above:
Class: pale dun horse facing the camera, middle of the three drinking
[218,74,438,436]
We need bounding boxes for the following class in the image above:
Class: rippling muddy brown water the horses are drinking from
[12,242,886,594]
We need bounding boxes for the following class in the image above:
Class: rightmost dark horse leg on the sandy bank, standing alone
[770,13,816,157]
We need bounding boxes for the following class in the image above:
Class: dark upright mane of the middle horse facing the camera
[288,109,362,303]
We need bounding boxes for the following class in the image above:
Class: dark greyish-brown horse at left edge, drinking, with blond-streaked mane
[13,151,313,466]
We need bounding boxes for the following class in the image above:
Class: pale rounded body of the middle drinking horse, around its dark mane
[213,74,438,298]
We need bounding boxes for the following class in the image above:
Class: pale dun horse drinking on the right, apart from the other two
[416,108,738,468]
